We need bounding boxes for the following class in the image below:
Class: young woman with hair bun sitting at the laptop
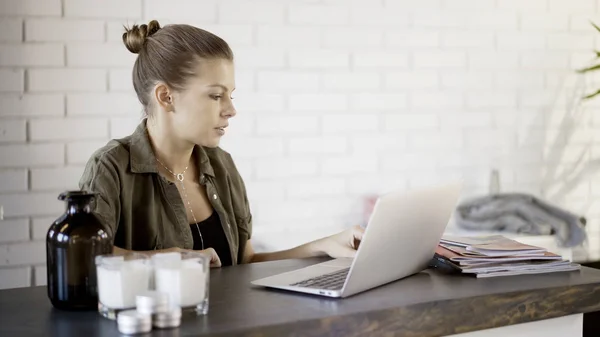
[79,21,363,267]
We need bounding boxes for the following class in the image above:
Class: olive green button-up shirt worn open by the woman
[79,119,252,265]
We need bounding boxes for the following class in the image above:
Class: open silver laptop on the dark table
[251,183,461,298]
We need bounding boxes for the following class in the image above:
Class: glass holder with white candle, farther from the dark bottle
[152,252,210,315]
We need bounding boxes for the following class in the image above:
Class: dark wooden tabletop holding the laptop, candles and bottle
[0,259,600,337]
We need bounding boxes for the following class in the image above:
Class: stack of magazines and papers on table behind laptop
[432,235,581,278]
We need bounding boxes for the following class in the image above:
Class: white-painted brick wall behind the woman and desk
[0,0,600,288]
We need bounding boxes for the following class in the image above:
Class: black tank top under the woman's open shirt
[190,210,232,266]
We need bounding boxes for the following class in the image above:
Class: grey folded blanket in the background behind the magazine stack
[455,193,586,247]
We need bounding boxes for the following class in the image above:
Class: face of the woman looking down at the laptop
[169,59,236,147]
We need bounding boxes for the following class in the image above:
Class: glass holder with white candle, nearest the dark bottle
[96,252,152,319]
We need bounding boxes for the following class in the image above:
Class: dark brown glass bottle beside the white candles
[46,191,113,310]
